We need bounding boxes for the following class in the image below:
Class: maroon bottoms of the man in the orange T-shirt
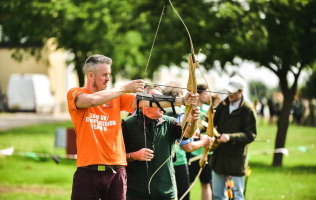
[71,167,126,200]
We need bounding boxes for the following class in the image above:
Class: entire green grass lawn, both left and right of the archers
[0,119,316,200]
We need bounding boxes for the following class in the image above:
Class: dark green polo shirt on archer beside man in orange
[123,116,176,199]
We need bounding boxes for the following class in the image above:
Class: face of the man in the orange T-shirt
[93,64,111,91]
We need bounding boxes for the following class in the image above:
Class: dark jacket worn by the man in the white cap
[199,98,257,176]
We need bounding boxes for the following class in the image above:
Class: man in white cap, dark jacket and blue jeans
[199,76,257,200]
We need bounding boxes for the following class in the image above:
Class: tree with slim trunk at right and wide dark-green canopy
[127,0,316,166]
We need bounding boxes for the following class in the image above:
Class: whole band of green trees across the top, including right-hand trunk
[0,0,316,166]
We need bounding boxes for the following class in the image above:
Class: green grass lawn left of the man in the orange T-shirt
[0,122,76,200]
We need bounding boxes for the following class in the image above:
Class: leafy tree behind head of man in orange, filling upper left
[0,0,158,87]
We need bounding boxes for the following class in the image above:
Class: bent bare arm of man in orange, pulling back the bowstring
[75,80,144,108]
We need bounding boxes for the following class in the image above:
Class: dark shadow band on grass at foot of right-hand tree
[249,162,316,174]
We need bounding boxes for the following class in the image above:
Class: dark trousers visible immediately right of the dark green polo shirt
[174,164,190,200]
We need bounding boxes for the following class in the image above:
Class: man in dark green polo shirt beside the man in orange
[122,86,200,200]
